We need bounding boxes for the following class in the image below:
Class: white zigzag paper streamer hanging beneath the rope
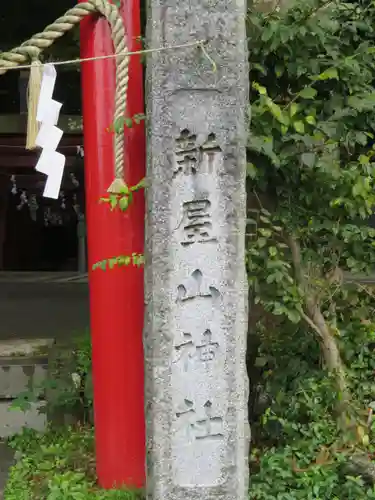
[35,64,65,200]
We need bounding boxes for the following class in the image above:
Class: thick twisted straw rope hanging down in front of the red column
[0,0,129,194]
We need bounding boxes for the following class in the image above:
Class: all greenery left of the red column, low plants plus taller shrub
[4,331,143,500]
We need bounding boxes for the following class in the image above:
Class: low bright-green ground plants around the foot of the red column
[4,427,141,500]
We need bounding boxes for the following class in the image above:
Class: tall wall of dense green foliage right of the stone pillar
[247,0,375,500]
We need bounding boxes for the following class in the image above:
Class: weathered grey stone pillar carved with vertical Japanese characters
[144,0,249,500]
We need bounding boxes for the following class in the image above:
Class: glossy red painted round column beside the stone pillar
[81,0,145,488]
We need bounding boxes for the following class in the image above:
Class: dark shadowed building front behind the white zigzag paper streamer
[0,68,84,271]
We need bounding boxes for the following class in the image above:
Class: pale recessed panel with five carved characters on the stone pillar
[172,129,226,486]
